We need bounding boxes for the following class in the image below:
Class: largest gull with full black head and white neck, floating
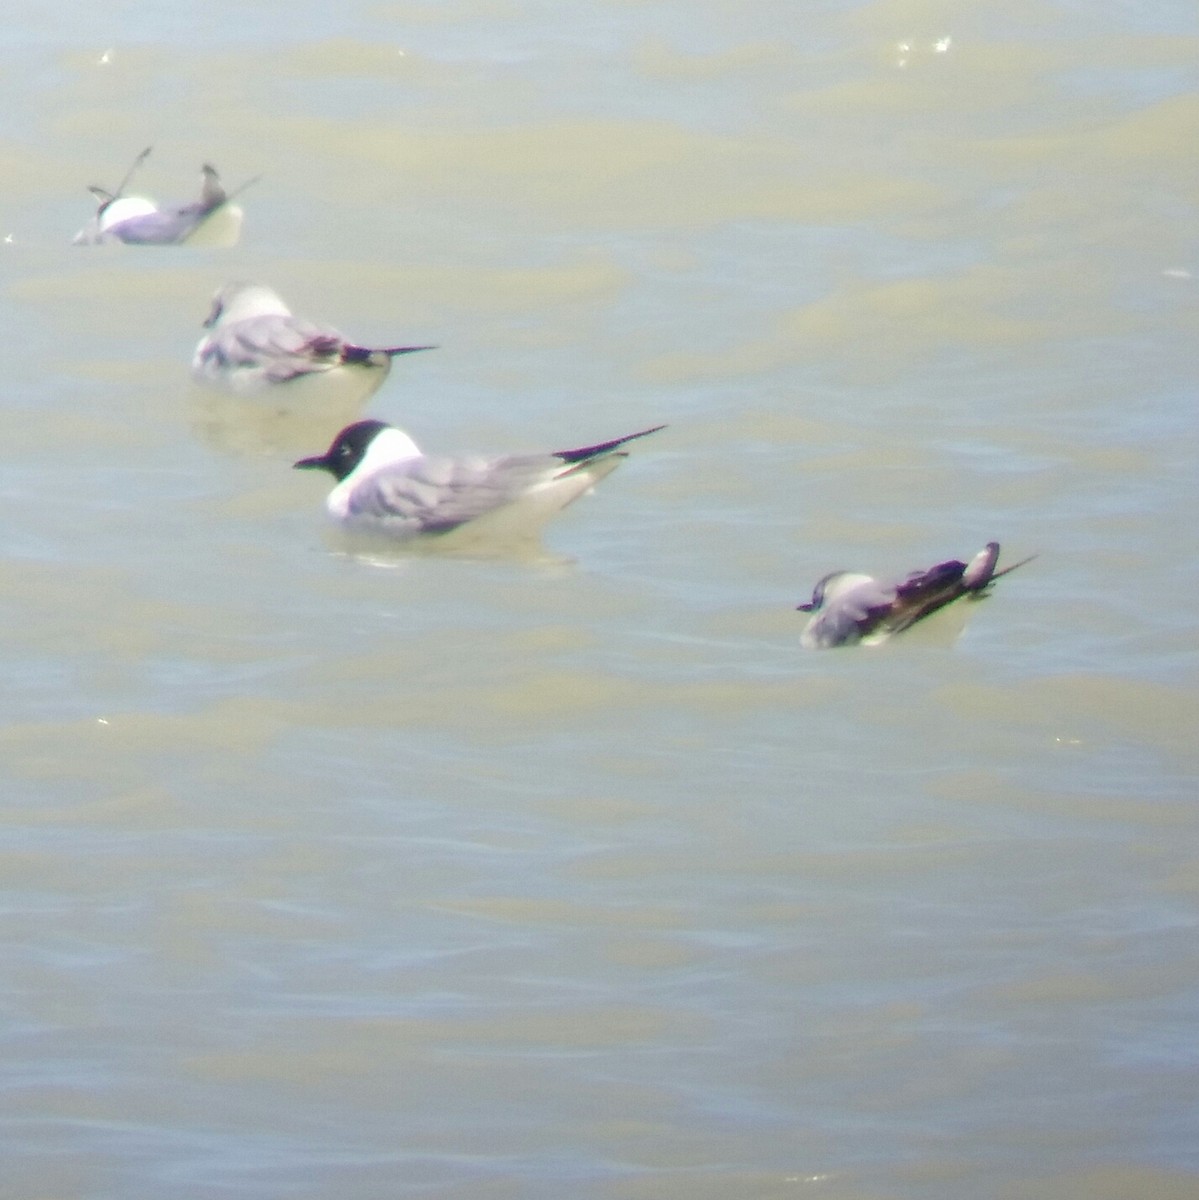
[295,420,665,540]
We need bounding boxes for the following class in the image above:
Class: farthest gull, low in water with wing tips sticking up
[72,146,257,246]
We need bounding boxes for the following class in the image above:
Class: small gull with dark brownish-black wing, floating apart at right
[798,541,1036,650]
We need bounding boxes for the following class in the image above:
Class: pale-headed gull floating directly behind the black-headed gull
[192,282,434,398]
